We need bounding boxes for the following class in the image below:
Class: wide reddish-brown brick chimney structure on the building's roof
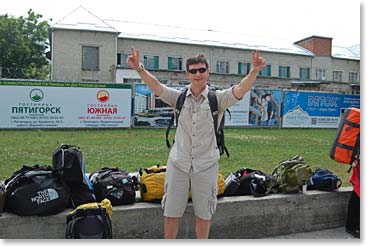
[294,36,333,56]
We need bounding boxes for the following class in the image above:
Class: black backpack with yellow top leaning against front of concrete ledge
[66,199,112,239]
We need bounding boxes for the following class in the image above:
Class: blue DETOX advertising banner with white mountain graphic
[283,91,360,128]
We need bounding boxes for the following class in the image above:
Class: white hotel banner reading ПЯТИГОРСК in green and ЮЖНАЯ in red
[0,80,131,128]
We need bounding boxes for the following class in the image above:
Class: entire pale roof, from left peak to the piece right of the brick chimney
[51,6,359,60]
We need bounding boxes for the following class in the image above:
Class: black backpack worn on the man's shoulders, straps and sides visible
[166,87,230,157]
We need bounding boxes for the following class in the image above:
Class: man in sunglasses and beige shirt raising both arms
[126,49,265,239]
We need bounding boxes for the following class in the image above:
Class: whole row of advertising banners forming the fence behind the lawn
[0,79,360,129]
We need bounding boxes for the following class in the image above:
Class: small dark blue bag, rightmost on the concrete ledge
[307,168,342,191]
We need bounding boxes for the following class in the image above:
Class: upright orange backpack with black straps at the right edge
[329,108,360,165]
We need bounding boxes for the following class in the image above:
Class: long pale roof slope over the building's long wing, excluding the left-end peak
[105,20,314,56]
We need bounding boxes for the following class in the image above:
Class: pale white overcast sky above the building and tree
[0,0,364,47]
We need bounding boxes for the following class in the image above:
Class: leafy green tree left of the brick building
[0,9,50,79]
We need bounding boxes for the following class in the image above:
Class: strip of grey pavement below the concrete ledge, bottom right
[264,227,360,239]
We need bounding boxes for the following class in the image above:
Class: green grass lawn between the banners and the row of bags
[0,128,350,186]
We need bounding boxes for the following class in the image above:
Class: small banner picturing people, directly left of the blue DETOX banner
[248,89,282,126]
